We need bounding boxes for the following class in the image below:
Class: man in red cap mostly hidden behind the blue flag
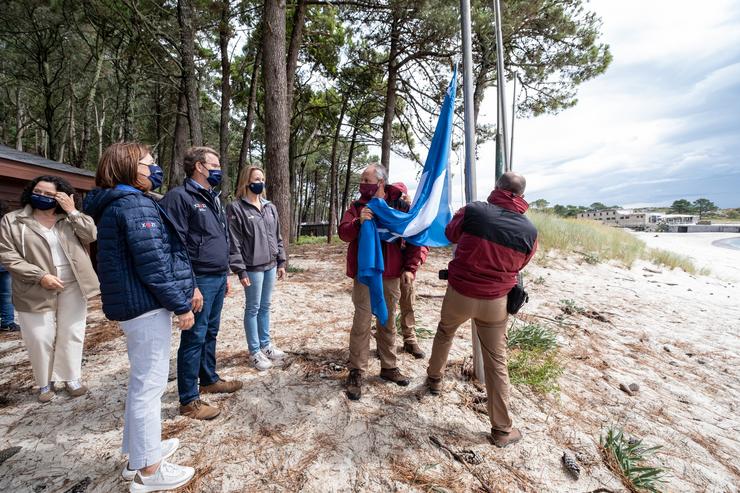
[387,181,429,359]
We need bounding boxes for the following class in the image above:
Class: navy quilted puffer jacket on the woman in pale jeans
[85,185,195,320]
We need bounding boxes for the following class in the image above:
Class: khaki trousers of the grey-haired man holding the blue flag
[349,278,401,372]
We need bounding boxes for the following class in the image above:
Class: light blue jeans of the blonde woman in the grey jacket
[244,267,277,354]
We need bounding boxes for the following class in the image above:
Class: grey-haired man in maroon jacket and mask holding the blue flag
[339,164,421,400]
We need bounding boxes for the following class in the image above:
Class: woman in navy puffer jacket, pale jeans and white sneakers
[85,142,195,492]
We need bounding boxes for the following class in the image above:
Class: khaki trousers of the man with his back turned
[427,285,512,433]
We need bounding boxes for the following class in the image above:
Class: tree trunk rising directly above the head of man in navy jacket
[177,0,203,146]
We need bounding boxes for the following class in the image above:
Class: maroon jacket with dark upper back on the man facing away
[445,190,537,299]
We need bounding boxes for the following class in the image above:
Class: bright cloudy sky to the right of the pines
[391,0,740,207]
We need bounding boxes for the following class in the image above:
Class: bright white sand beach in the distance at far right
[635,233,740,282]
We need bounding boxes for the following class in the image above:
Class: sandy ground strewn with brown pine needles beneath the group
[0,246,740,492]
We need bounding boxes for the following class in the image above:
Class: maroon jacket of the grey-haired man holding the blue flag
[339,201,429,279]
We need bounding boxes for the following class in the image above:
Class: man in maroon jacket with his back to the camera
[427,172,537,447]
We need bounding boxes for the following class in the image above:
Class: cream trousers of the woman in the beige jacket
[17,266,87,387]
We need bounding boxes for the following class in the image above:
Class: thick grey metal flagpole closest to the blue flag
[460,0,485,383]
